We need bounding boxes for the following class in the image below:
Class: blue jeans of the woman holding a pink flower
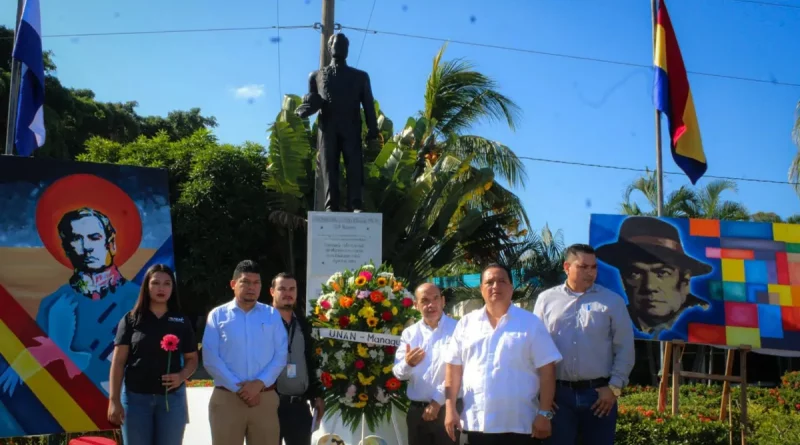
[121,386,189,445]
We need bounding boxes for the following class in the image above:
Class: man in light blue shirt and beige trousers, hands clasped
[202,260,289,445]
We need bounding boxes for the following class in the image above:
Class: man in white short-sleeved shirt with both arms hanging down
[445,264,561,445]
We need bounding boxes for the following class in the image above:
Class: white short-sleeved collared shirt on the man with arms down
[445,305,561,434]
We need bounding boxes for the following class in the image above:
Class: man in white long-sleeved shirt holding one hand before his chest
[392,283,458,445]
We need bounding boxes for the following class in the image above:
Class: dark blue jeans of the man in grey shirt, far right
[545,384,617,445]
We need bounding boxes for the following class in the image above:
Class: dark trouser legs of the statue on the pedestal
[318,127,364,211]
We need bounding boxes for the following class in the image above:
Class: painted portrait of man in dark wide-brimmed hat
[597,216,713,340]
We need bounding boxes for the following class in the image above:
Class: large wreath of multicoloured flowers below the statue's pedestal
[312,263,419,432]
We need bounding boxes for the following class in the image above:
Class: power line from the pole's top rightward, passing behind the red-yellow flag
[342,25,800,88]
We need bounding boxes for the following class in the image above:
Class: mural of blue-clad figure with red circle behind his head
[0,157,174,437]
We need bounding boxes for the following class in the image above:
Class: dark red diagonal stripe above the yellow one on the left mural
[0,285,114,430]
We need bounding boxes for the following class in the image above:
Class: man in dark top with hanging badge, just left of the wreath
[269,272,325,445]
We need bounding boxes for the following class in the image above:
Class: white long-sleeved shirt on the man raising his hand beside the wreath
[392,315,457,405]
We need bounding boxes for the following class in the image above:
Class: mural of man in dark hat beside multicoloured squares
[589,215,800,351]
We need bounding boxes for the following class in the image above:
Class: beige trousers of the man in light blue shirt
[208,388,280,445]
